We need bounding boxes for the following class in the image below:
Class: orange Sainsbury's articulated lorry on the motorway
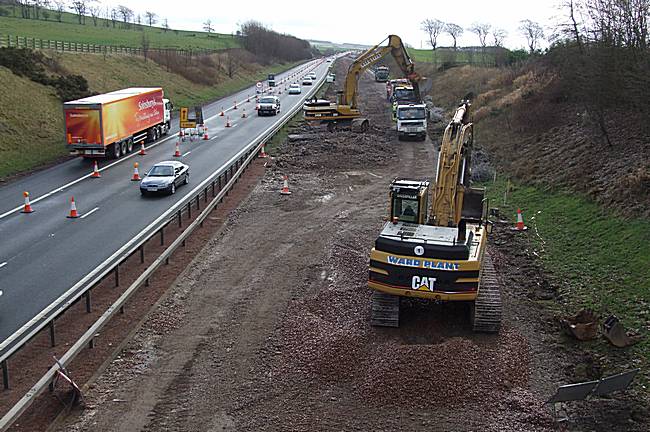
[63,87,172,159]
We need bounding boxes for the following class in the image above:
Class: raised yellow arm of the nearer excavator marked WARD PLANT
[430,100,473,226]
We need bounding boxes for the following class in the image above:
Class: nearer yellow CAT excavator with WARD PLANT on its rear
[368,95,501,333]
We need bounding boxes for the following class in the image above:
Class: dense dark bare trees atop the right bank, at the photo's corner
[548,0,650,145]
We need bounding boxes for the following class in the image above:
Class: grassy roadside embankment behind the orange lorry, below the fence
[0,51,291,181]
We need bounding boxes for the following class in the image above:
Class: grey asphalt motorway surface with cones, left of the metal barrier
[0,60,330,348]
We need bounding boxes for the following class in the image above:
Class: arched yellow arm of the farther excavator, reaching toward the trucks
[339,35,420,108]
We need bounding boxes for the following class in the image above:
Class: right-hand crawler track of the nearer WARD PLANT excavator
[472,252,502,333]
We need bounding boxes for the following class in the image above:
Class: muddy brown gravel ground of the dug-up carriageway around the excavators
[53,59,648,431]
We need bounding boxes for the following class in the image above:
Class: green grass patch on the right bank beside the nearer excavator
[485,180,650,380]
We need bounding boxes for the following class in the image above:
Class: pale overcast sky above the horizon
[102,0,559,48]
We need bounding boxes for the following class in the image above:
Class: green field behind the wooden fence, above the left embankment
[0,6,239,50]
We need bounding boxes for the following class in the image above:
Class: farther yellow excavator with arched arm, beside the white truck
[303,35,420,132]
